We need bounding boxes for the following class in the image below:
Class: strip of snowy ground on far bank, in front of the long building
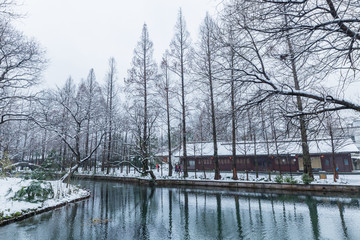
[79,165,360,185]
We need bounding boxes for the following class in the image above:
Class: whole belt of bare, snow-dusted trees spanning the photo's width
[0,0,360,179]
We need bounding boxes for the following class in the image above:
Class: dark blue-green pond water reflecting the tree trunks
[0,181,360,240]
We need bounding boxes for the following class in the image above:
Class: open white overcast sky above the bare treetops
[17,0,220,88]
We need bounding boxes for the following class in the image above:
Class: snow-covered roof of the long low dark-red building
[173,139,359,157]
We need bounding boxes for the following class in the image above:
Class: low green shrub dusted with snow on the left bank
[12,181,54,203]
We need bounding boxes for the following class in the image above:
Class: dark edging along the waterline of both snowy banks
[0,174,360,227]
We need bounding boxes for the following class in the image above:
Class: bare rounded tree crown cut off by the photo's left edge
[0,12,45,125]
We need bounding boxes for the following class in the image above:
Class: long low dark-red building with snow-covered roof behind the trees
[173,139,359,172]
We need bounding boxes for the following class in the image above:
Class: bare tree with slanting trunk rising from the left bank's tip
[33,78,104,181]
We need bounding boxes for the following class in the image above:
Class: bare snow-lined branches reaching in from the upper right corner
[219,0,360,114]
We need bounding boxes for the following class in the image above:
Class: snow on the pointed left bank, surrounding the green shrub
[0,178,88,219]
